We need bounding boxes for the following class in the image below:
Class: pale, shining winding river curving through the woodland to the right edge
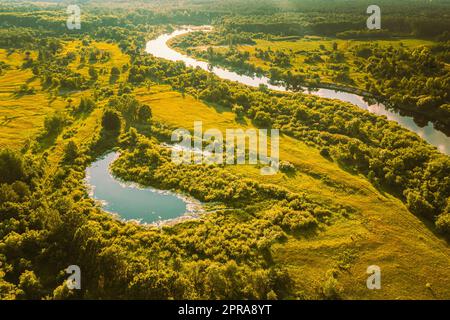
[146,26,450,155]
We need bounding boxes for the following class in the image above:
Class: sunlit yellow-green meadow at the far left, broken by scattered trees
[0,41,129,148]
